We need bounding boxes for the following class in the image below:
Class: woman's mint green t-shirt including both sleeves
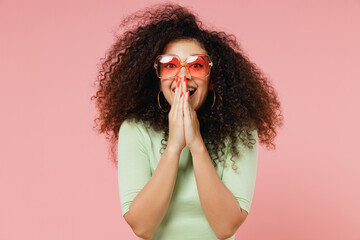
[118,120,258,240]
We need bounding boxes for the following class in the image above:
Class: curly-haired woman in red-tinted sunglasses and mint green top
[93,4,282,240]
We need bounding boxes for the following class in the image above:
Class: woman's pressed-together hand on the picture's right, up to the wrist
[183,76,203,151]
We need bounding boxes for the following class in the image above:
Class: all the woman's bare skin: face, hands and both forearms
[124,40,247,239]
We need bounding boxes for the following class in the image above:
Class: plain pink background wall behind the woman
[0,0,360,240]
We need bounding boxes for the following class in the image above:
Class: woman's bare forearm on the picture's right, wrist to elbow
[191,144,242,239]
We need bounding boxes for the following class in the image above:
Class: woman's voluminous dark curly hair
[91,4,283,169]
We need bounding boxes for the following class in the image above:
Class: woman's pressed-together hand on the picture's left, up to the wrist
[167,77,186,153]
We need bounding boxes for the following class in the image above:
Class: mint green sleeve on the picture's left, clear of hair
[118,120,151,216]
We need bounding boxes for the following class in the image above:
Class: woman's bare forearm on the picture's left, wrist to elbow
[126,149,180,238]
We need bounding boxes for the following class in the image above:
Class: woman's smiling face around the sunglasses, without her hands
[160,39,210,111]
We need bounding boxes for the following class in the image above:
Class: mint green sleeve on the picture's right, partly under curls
[222,130,258,214]
